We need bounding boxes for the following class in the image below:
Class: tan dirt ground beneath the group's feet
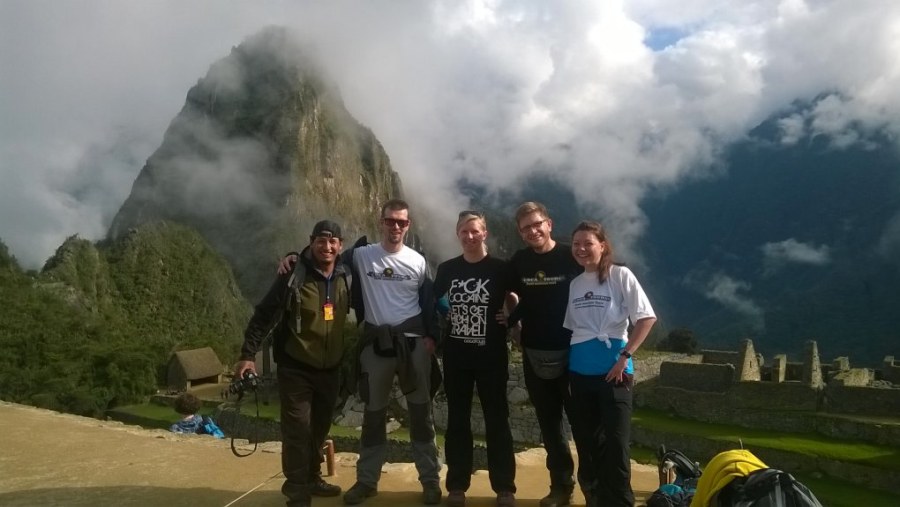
[0,402,658,507]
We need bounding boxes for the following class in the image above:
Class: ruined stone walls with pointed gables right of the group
[635,340,900,446]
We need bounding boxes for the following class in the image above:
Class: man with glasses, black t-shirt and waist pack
[509,202,594,507]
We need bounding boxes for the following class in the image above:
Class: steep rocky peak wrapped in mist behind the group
[109,27,402,300]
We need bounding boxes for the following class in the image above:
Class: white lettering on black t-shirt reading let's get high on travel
[447,278,491,345]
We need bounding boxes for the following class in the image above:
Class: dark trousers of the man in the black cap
[278,366,340,500]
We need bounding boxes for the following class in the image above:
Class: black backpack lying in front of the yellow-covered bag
[717,468,822,507]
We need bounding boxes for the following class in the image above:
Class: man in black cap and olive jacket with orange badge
[234,220,350,507]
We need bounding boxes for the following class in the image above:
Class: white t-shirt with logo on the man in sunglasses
[353,243,427,326]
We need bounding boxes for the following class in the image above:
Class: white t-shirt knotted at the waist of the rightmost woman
[563,266,656,346]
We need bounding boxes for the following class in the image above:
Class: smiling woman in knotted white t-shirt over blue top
[564,221,656,507]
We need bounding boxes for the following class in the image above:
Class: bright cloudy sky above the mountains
[0,0,900,266]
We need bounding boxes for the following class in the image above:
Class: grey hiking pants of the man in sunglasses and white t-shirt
[356,338,441,487]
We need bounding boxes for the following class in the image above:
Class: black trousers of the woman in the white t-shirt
[569,372,634,507]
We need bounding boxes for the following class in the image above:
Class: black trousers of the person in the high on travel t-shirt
[444,366,516,493]
